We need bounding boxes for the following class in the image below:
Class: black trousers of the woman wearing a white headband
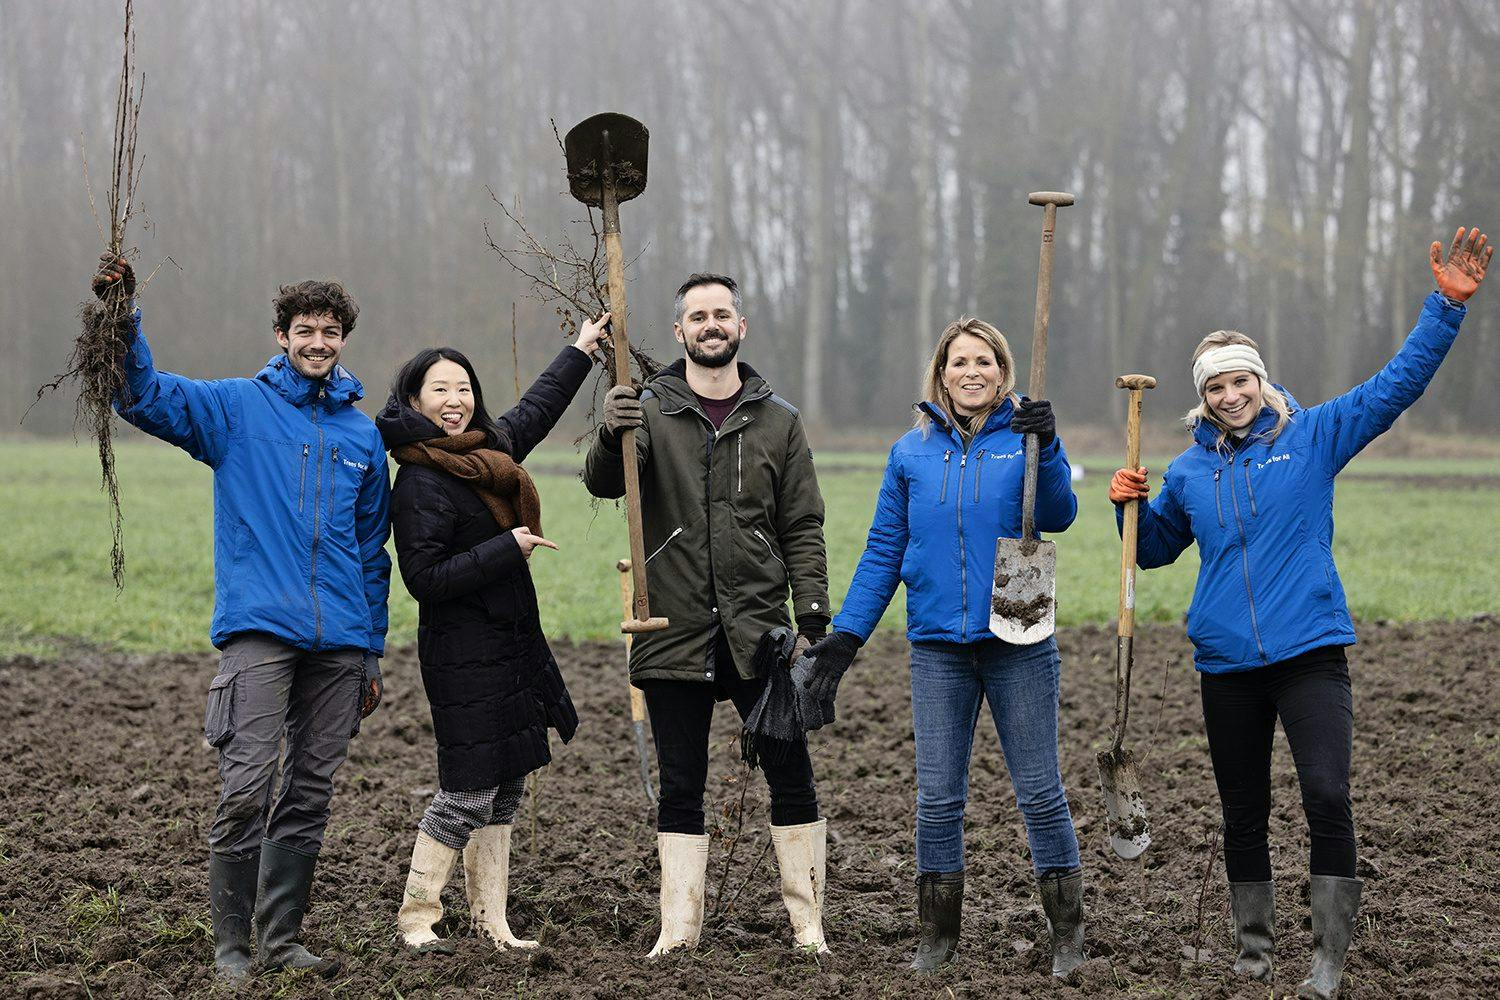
[1200,646,1355,882]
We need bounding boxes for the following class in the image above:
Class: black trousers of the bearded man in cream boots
[641,633,818,834]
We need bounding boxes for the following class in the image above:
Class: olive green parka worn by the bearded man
[584,360,830,682]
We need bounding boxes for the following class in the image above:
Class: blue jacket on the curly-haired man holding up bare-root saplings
[116,310,390,655]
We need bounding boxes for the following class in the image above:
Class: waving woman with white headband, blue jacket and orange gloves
[1110,229,1494,1000]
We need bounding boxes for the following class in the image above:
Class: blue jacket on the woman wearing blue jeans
[834,400,1079,643]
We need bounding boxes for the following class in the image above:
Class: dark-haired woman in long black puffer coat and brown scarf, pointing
[375,313,609,952]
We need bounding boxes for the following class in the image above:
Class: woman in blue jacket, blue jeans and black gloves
[806,319,1083,975]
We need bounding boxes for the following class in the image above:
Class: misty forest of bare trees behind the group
[0,0,1500,435]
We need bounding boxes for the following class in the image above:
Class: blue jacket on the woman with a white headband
[1136,292,1464,673]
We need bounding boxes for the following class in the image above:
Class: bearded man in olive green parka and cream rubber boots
[584,274,830,957]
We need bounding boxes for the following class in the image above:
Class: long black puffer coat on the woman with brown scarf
[375,346,591,792]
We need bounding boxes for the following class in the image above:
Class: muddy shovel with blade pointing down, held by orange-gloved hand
[1098,375,1157,861]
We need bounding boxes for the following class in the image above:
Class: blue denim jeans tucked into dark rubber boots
[912,639,1079,874]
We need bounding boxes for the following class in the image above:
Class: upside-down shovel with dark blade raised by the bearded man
[563,112,668,634]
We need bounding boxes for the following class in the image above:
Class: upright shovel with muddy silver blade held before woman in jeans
[990,190,1073,646]
